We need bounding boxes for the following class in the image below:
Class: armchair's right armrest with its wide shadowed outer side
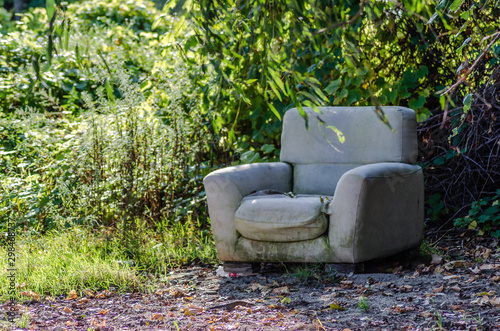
[329,163,424,263]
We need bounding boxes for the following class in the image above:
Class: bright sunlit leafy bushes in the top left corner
[0,1,168,113]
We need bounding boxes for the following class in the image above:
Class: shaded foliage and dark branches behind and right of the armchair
[186,0,500,235]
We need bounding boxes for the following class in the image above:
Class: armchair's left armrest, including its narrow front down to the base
[203,162,292,261]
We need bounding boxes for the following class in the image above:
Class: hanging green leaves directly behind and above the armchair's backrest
[186,0,454,158]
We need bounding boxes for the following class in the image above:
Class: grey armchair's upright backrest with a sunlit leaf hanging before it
[280,106,417,195]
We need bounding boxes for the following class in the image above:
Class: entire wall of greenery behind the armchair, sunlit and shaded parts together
[0,0,500,256]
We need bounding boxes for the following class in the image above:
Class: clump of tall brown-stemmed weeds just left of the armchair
[68,67,207,230]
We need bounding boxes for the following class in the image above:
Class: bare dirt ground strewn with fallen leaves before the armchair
[1,233,500,330]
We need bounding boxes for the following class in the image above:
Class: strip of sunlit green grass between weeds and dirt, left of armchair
[0,224,216,301]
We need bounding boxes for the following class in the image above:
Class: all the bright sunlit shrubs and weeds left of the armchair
[0,1,211,249]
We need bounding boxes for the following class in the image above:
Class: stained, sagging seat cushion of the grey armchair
[234,194,331,242]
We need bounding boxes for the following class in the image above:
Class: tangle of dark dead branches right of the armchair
[418,64,500,216]
